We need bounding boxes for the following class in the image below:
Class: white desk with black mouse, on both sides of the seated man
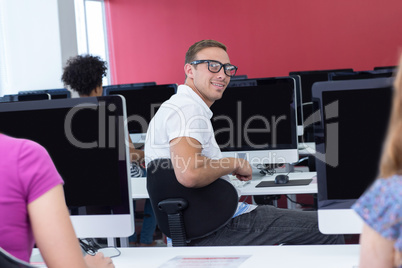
[131,172,317,199]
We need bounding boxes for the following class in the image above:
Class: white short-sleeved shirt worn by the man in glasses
[144,85,256,217]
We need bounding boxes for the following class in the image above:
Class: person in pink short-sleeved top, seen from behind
[0,133,114,268]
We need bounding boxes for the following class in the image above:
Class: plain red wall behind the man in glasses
[105,0,402,84]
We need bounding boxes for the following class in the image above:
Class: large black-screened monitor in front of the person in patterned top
[312,78,392,234]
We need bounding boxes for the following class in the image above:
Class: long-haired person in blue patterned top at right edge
[352,56,402,268]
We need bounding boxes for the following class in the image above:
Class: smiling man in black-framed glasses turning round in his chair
[145,40,343,246]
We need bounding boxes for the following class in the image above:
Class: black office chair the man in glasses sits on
[147,158,239,247]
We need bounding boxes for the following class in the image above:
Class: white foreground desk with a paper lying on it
[32,245,360,268]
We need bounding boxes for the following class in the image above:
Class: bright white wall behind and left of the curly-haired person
[0,0,76,96]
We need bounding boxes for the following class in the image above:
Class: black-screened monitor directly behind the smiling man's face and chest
[211,78,299,170]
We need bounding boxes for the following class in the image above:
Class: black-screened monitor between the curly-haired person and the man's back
[104,84,177,145]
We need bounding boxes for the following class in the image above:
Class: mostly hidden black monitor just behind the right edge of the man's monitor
[289,68,353,142]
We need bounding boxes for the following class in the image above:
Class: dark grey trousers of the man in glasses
[190,205,344,246]
